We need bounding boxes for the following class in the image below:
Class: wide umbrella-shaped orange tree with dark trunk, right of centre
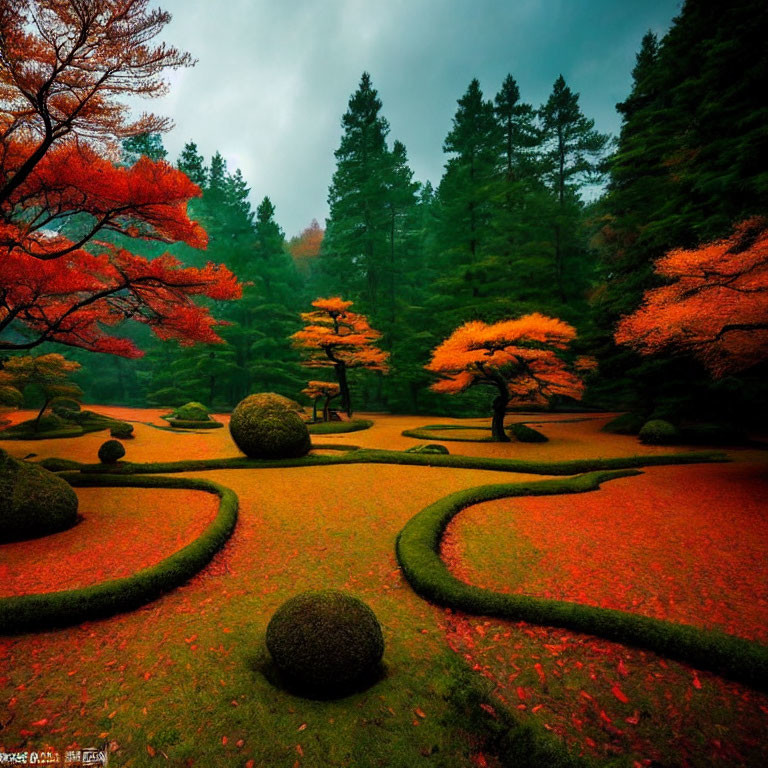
[425,313,595,442]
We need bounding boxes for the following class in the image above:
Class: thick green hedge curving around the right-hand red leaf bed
[395,470,768,690]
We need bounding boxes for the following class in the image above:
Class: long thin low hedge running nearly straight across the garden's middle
[34,445,729,476]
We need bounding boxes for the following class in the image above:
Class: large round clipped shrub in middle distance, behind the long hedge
[229,394,311,459]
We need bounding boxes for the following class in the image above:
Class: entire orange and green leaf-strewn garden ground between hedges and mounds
[0,408,768,768]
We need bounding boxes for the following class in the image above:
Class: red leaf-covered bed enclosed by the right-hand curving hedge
[443,463,768,643]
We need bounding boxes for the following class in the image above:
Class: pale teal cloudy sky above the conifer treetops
[147,0,680,236]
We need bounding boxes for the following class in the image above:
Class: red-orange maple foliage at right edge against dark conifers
[615,217,768,376]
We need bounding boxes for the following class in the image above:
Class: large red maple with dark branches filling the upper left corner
[0,0,240,357]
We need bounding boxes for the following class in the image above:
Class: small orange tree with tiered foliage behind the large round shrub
[291,296,389,417]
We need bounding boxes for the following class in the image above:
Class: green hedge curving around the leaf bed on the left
[0,472,238,635]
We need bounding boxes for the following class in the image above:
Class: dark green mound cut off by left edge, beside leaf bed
[0,450,77,542]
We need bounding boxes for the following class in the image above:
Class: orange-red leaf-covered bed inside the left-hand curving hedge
[0,488,218,598]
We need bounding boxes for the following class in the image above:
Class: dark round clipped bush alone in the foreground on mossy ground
[267,589,384,698]
